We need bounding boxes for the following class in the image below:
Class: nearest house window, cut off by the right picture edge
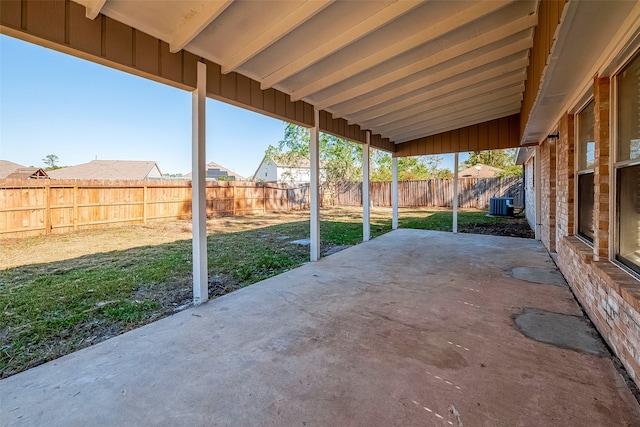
[615,55,640,273]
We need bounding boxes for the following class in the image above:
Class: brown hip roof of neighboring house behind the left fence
[49,160,162,180]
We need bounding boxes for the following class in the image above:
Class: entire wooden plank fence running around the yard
[0,178,523,238]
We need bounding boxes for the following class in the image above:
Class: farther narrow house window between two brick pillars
[578,100,595,242]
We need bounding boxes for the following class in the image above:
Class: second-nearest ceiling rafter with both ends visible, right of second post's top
[331,39,532,117]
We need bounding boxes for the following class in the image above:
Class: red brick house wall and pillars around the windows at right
[556,78,640,392]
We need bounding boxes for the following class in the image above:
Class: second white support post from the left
[309,109,320,261]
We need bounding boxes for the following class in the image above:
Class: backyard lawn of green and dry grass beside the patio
[0,208,516,378]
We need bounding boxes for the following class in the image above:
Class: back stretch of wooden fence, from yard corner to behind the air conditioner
[333,178,524,209]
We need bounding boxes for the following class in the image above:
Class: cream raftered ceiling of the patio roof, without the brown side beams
[72,0,537,142]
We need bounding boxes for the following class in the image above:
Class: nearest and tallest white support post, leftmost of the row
[191,62,209,305]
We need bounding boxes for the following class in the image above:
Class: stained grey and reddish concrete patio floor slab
[0,230,640,427]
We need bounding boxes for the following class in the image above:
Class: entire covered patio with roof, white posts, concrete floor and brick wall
[0,0,640,426]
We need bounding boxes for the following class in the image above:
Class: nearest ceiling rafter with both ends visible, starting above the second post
[315,15,538,109]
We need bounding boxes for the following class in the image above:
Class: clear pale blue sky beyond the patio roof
[0,35,466,177]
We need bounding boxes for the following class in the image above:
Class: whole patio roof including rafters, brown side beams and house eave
[0,0,638,156]
